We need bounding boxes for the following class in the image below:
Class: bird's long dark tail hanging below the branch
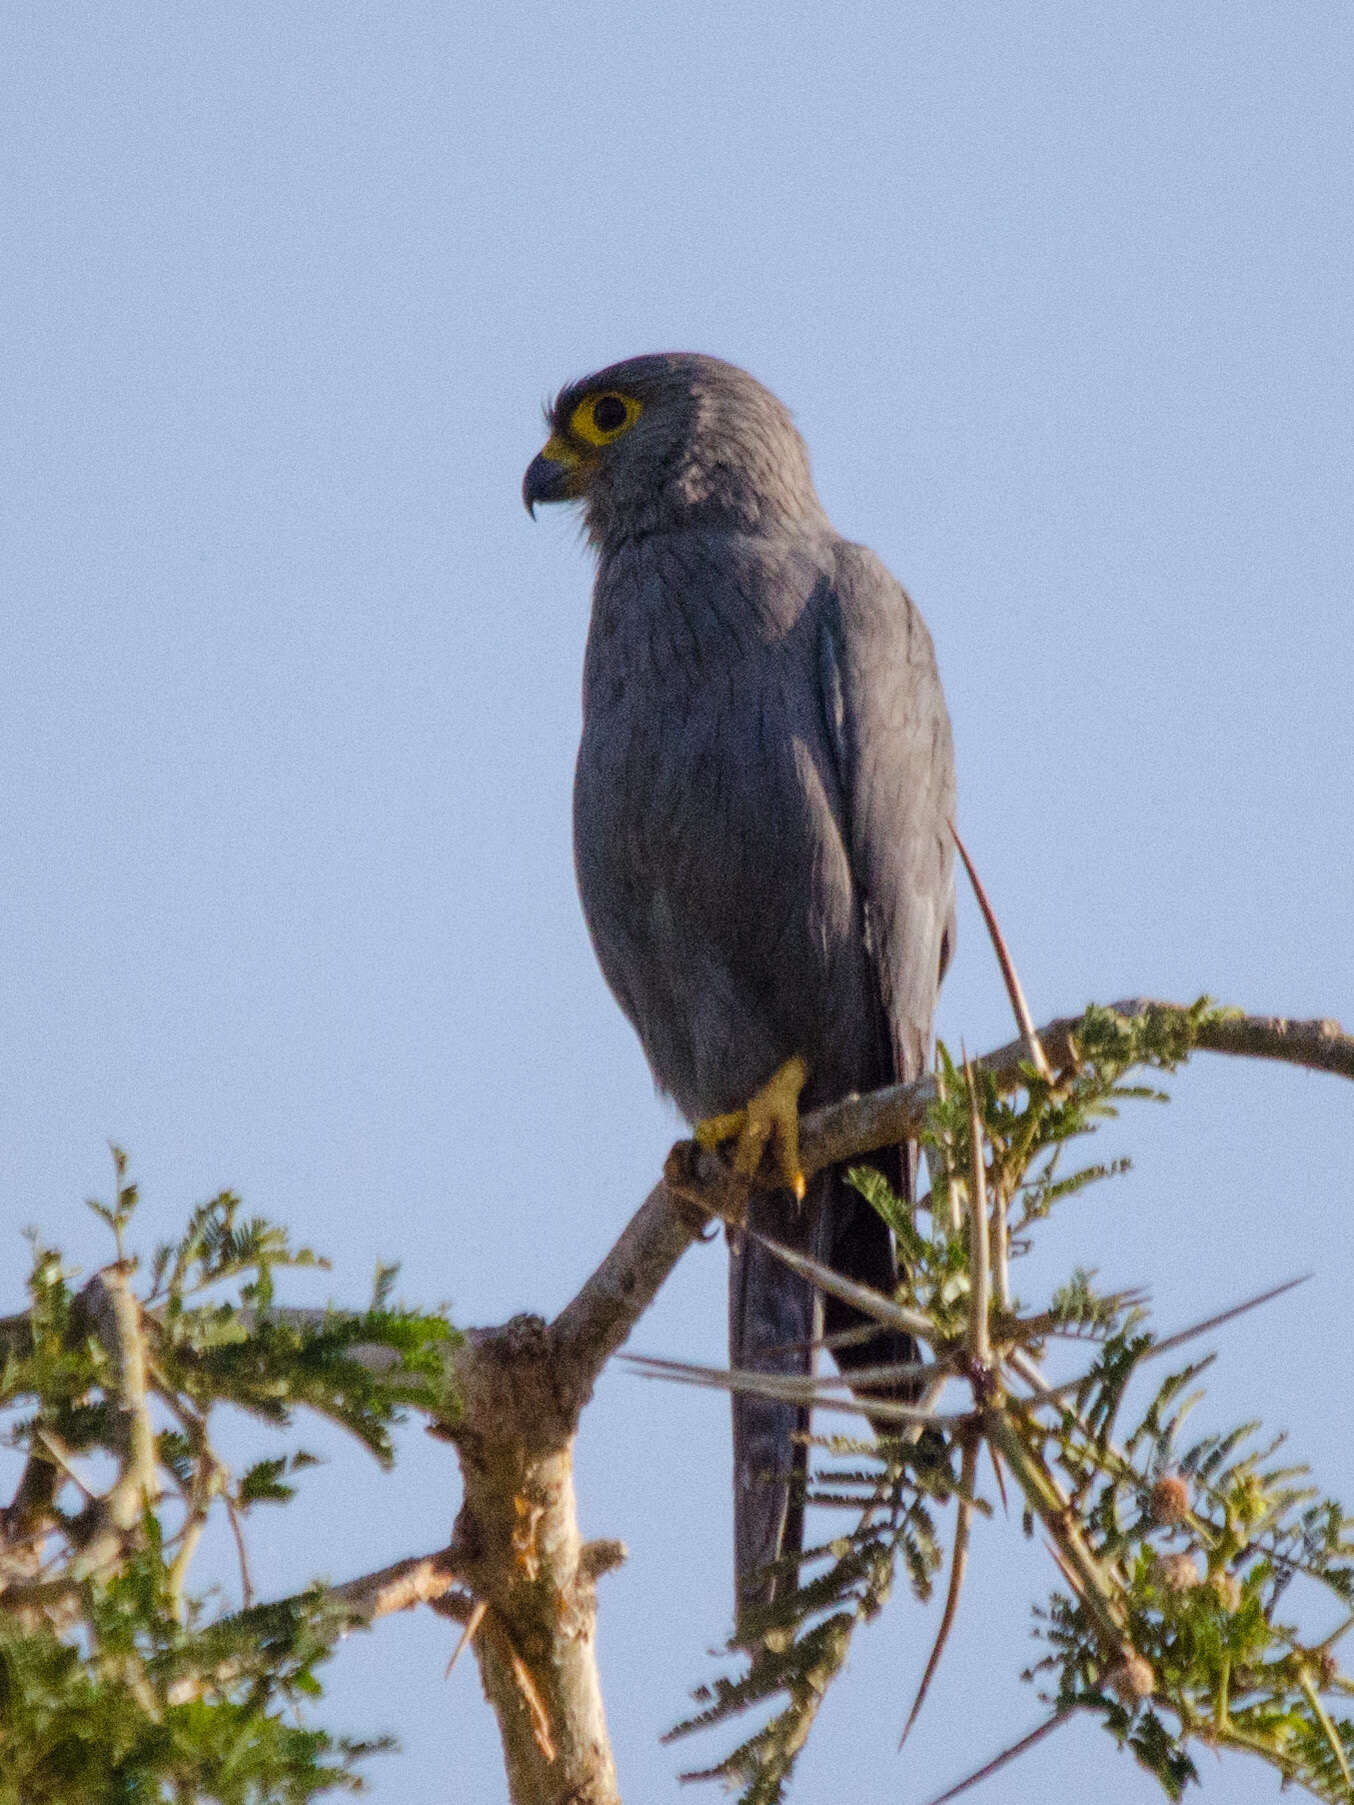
[729,1168,917,1621]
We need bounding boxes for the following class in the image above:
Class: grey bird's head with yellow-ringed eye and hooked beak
[522,352,825,545]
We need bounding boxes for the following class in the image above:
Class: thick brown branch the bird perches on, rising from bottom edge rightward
[431,1000,1354,1805]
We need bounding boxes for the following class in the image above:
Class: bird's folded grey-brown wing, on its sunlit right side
[820,542,955,1079]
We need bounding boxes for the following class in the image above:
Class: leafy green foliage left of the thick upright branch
[0,1150,453,1805]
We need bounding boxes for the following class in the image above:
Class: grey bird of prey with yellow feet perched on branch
[522,352,955,1626]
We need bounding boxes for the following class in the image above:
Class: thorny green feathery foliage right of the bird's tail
[673,1002,1354,1805]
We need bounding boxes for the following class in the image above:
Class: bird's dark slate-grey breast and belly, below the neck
[574,545,870,1114]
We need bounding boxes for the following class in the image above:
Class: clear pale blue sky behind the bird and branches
[0,0,1354,1805]
